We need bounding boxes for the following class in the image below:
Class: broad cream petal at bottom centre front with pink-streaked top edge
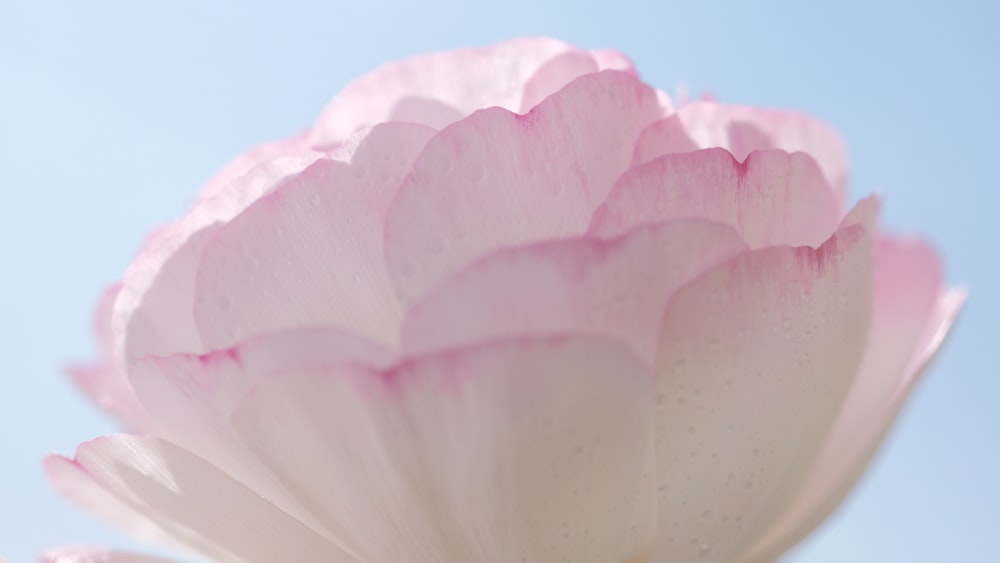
[234,337,655,563]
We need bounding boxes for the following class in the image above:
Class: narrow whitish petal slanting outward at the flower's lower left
[47,434,357,563]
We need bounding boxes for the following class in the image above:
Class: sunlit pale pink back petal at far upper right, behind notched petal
[636,100,849,209]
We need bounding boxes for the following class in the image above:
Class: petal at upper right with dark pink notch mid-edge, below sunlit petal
[590,149,840,248]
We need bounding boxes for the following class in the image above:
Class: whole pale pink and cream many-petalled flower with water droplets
[46,39,964,563]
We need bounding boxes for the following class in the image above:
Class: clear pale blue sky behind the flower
[0,0,1000,563]
